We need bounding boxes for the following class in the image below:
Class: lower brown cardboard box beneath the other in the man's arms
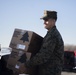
[7,49,36,75]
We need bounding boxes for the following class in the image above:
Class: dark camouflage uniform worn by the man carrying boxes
[26,26,64,75]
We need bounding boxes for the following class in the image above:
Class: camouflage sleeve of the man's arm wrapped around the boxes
[25,37,56,66]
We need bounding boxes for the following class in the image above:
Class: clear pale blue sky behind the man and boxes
[0,0,76,47]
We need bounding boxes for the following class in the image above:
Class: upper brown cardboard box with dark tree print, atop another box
[9,29,43,53]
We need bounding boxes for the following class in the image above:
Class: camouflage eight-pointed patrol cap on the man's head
[40,10,57,20]
